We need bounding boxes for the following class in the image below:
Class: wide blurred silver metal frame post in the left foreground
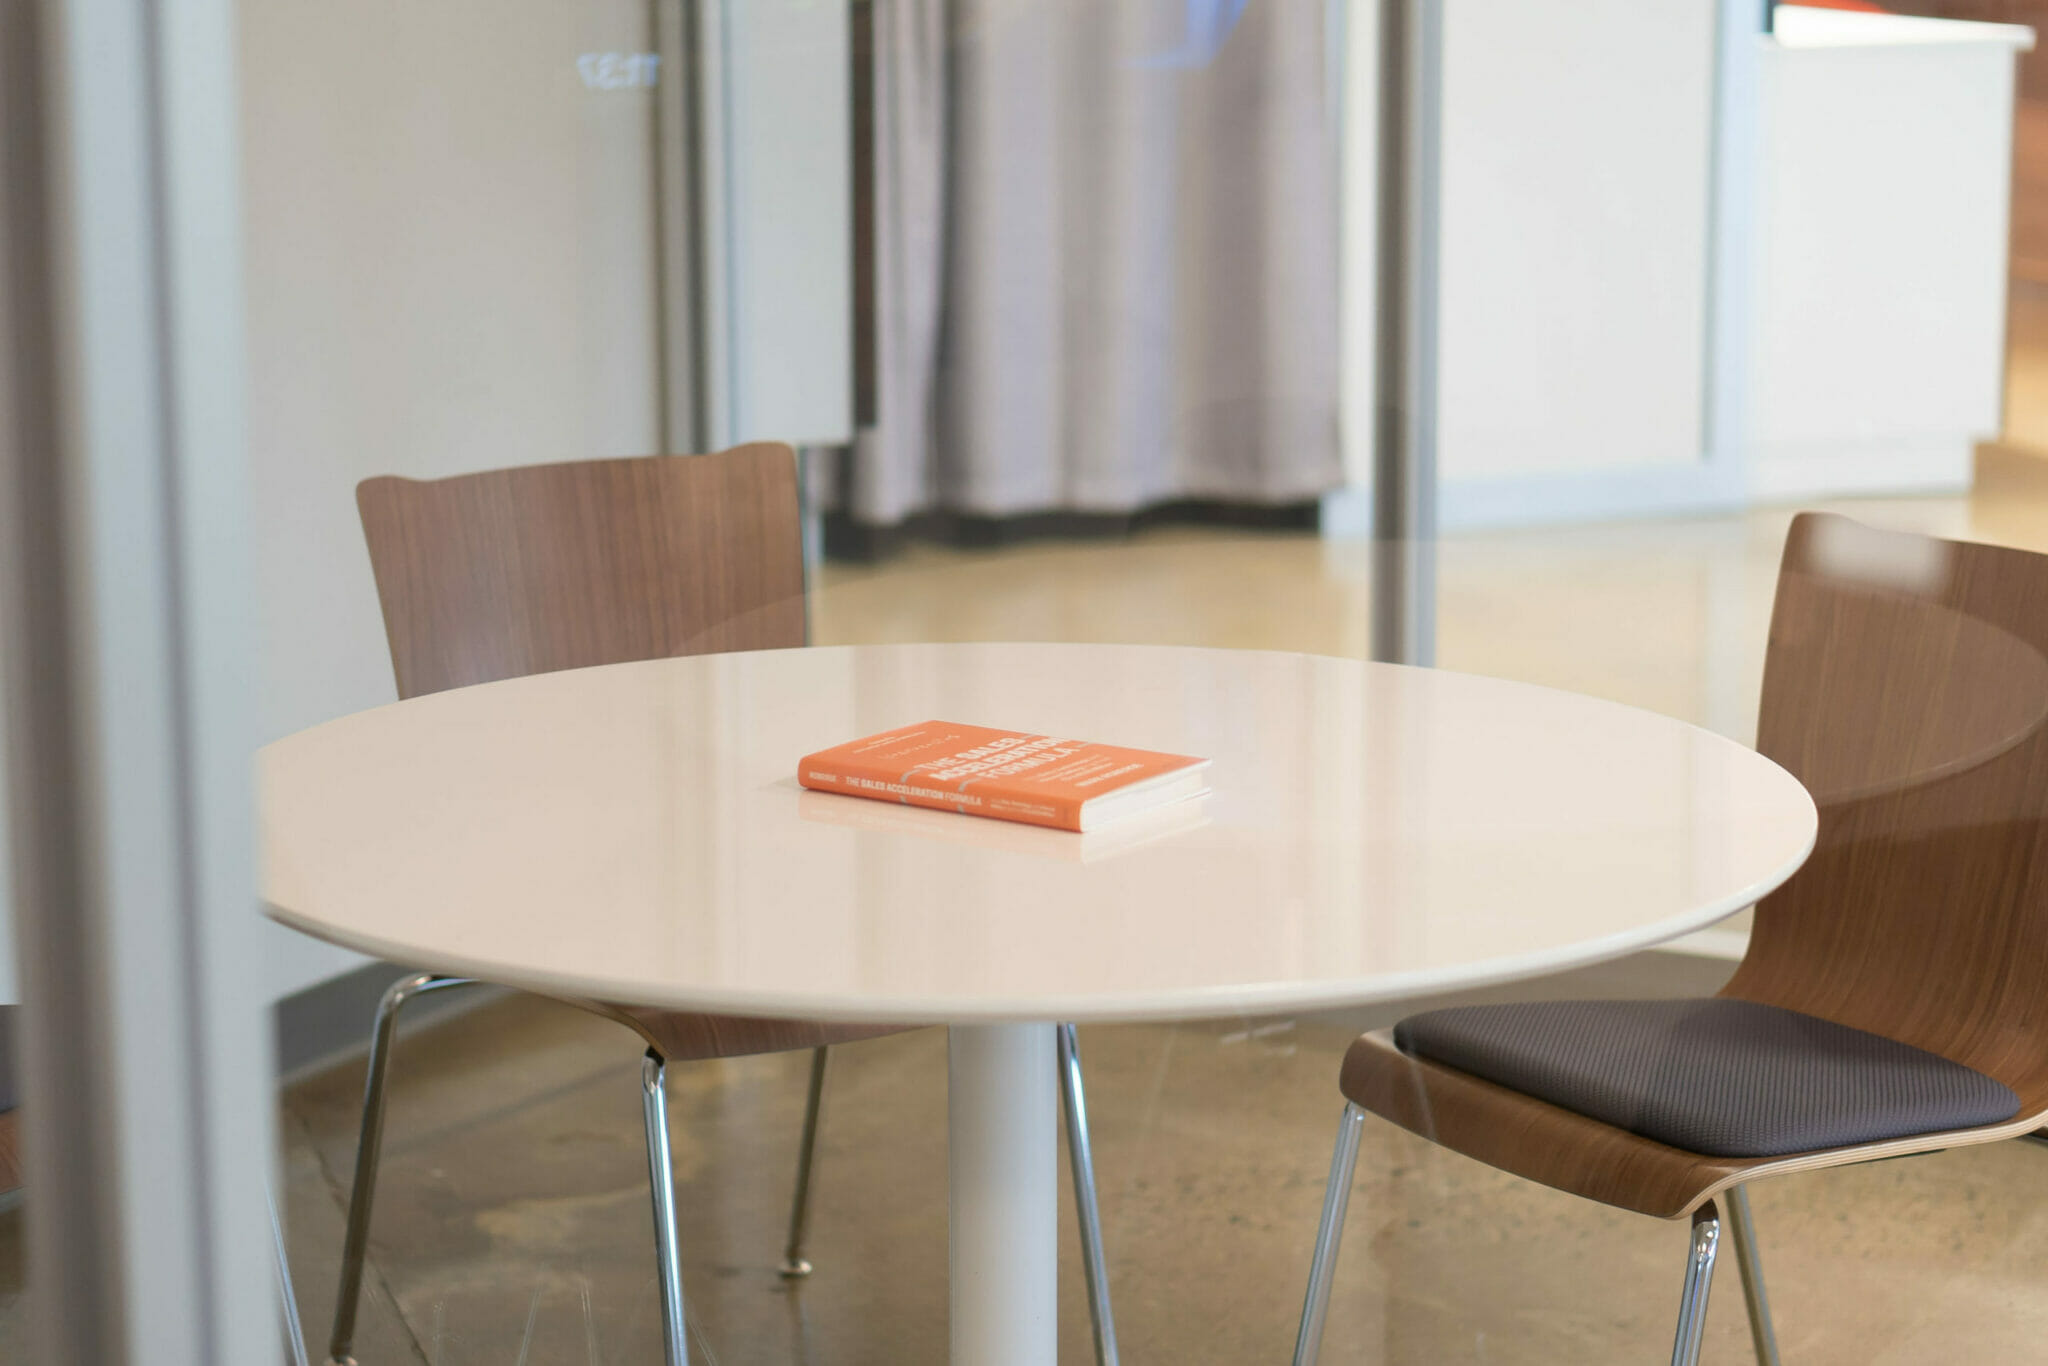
[0,0,279,1366]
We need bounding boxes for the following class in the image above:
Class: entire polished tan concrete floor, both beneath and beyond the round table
[19,456,2048,1366]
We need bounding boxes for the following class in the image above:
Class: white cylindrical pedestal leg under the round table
[946,1024,1059,1366]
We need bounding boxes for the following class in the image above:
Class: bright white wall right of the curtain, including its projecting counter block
[1325,0,2032,535]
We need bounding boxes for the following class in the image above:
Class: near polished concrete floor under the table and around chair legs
[264,954,2048,1366]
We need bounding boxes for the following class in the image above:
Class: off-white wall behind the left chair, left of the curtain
[242,0,852,993]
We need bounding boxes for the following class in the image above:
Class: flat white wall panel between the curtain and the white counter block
[1339,0,1718,499]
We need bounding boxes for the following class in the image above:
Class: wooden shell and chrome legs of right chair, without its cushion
[1294,514,2048,1366]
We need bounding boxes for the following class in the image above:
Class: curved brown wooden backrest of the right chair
[1726,514,2048,1108]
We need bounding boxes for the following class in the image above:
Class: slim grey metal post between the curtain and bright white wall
[1372,0,1444,664]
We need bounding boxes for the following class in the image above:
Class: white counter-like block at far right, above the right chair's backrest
[1749,8,2030,500]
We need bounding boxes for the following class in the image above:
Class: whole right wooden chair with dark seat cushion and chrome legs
[1294,514,2048,1366]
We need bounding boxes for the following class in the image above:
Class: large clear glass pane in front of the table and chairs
[16,0,2048,1366]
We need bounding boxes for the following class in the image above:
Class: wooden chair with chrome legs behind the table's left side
[344,444,1116,1366]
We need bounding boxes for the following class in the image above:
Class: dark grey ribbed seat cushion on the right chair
[1395,997,2019,1157]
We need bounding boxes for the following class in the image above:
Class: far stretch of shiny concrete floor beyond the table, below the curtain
[811,446,2048,739]
